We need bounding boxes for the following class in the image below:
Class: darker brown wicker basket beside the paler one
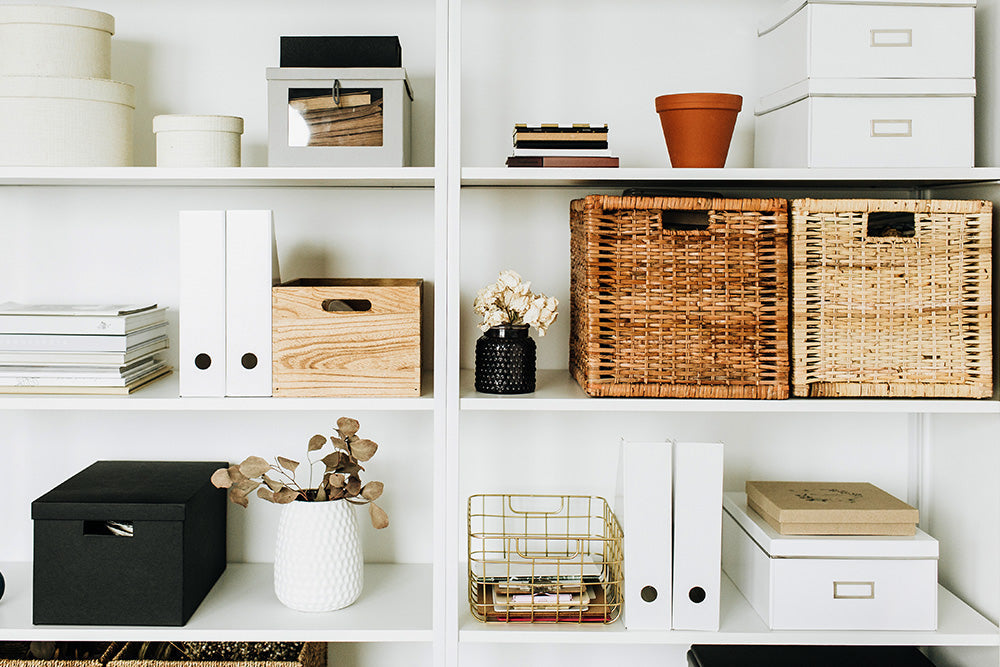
[569,195,789,398]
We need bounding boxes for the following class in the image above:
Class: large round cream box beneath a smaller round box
[0,76,135,167]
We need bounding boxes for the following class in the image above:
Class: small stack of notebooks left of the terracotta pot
[507,123,618,167]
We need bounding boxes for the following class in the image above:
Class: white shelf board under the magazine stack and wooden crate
[0,370,434,412]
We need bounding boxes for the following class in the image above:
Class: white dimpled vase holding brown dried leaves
[274,500,364,611]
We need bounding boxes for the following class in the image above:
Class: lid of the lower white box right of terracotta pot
[754,79,976,116]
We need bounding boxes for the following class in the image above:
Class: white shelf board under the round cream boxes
[0,167,437,188]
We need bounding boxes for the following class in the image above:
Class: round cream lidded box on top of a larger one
[0,5,115,79]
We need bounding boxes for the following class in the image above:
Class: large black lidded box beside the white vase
[31,461,229,625]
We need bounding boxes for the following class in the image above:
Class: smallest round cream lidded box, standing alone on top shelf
[153,114,243,167]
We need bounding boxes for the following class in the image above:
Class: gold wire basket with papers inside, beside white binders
[468,494,622,623]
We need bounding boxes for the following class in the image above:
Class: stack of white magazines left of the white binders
[0,303,172,394]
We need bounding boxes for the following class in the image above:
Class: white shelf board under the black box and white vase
[0,563,432,642]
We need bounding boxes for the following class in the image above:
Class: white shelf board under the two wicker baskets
[460,369,1000,414]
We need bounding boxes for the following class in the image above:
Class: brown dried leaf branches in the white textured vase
[212,417,389,528]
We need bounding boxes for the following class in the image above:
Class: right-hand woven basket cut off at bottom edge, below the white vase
[108,642,327,667]
